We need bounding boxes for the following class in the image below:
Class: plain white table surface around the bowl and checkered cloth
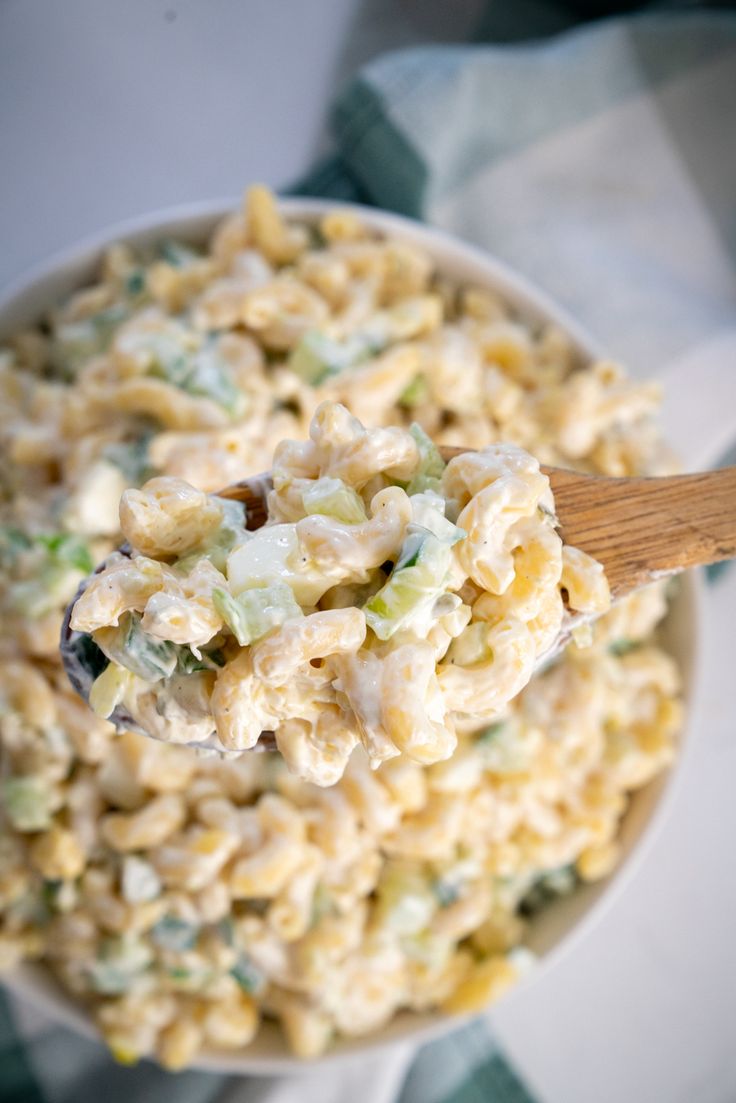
[0,0,736,1103]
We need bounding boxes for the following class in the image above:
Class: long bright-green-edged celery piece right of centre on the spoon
[363,529,451,640]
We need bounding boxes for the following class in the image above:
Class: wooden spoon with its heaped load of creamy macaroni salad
[62,403,736,785]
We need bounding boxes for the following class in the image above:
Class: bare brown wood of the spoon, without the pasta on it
[61,448,736,750]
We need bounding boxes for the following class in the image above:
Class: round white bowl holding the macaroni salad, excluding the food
[0,199,701,1073]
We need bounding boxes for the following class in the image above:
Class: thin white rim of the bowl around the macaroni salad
[0,196,703,1075]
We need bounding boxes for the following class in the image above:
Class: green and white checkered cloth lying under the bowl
[0,6,736,1103]
